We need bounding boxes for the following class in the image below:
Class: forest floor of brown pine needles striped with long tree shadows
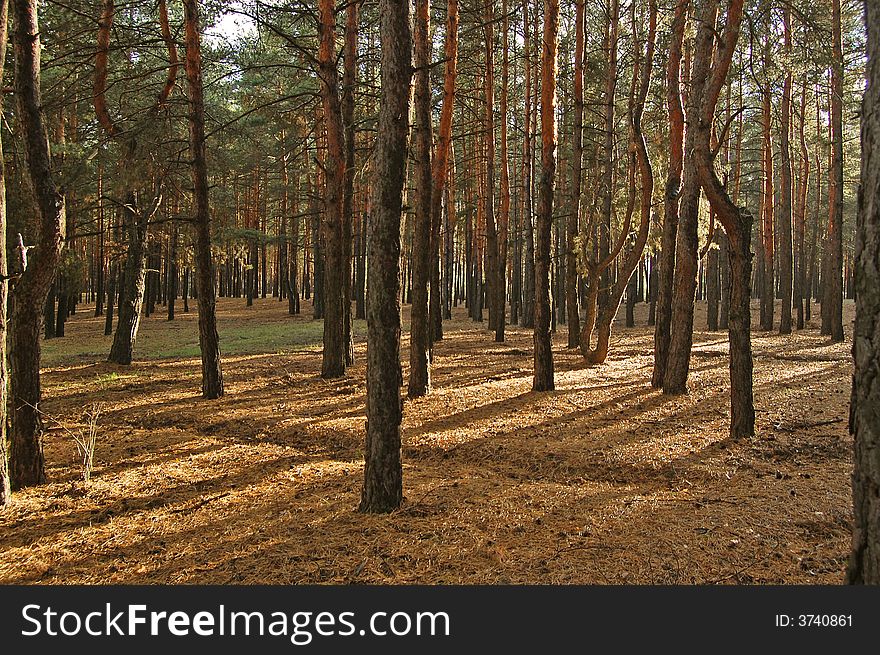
[0,300,853,584]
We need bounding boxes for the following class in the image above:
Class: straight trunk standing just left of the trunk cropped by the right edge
[822,0,844,341]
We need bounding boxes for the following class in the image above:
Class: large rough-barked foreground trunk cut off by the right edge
[846,2,880,584]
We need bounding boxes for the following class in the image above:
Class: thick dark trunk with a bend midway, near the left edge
[8,0,65,489]
